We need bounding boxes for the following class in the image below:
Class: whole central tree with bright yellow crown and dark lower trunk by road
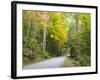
[49,12,68,56]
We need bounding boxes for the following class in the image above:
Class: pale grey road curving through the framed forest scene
[23,56,66,69]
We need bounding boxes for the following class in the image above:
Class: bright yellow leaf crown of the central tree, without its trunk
[50,13,68,44]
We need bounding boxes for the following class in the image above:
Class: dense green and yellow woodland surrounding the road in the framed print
[22,10,91,66]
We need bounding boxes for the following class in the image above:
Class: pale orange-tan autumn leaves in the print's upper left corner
[23,11,49,28]
